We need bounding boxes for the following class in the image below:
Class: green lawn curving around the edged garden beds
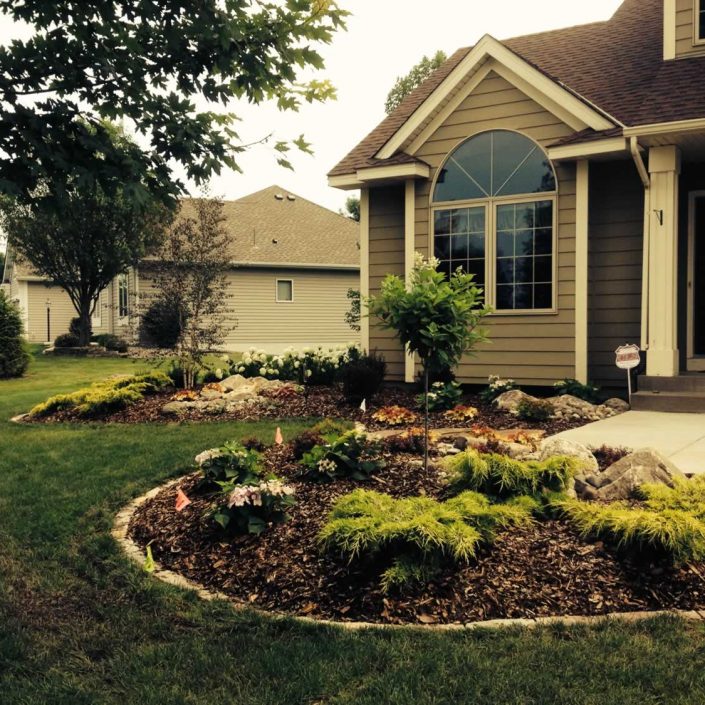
[0,359,705,705]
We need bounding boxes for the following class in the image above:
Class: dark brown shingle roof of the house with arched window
[330,0,705,176]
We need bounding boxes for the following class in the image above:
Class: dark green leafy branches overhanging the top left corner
[0,0,348,208]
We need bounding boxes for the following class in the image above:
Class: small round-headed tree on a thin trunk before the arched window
[367,253,490,467]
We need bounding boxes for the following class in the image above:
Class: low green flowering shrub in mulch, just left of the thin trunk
[301,431,386,481]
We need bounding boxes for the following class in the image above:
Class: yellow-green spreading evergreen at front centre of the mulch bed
[318,490,536,592]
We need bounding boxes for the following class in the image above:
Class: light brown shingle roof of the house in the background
[182,186,360,267]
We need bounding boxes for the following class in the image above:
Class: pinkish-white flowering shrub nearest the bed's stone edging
[212,479,296,534]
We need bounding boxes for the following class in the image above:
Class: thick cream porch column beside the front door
[646,145,681,377]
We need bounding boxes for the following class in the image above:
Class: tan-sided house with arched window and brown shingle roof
[329,0,705,412]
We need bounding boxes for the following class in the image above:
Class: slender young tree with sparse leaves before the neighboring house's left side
[142,198,237,389]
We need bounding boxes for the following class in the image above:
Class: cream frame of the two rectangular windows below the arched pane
[429,189,558,316]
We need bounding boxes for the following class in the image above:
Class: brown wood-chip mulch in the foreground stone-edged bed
[130,446,705,624]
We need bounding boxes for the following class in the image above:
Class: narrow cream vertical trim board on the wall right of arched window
[575,159,590,384]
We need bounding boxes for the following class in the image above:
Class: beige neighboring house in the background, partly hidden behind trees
[3,186,360,352]
